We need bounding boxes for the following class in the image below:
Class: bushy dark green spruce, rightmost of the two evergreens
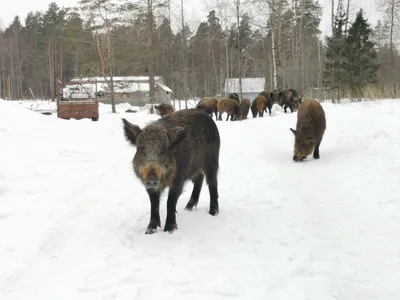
[345,9,379,96]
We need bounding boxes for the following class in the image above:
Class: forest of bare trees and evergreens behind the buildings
[0,0,400,100]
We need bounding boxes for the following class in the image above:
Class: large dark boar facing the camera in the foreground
[122,109,220,234]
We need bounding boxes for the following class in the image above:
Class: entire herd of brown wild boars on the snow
[122,90,326,234]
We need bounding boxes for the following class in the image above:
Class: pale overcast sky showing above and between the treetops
[0,0,380,34]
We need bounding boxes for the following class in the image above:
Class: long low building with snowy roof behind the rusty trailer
[71,76,173,106]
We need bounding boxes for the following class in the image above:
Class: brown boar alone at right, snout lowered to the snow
[290,99,326,162]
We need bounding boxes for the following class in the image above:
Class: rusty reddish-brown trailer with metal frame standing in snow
[57,81,99,121]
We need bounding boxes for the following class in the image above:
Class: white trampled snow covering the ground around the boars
[0,100,400,300]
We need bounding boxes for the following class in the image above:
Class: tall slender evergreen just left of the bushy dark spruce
[323,0,347,100]
